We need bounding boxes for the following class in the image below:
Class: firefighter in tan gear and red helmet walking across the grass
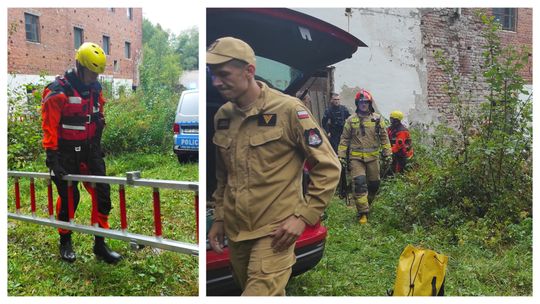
[338,89,392,224]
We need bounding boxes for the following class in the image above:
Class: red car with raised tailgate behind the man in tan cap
[206,8,366,295]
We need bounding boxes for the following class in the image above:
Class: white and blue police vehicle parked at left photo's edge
[173,89,199,162]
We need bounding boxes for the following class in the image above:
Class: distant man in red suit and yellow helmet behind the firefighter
[387,111,414,173]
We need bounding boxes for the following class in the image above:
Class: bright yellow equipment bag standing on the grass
[389,245,448,296]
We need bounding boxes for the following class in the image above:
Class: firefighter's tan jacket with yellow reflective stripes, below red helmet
[338,113,392,161]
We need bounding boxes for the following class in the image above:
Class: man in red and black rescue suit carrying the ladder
[41,42,122,264]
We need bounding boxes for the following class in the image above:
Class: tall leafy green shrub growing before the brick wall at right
[381,16,532,246]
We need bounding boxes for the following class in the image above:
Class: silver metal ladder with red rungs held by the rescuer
[8,171,199,255]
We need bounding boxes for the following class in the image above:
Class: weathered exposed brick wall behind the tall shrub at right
[420,8,532,125]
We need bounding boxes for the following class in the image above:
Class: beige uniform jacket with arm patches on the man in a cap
[213,82,341,242]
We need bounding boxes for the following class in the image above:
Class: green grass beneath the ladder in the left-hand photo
[8,154,198,296]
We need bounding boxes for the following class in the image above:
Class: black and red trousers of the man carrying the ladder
[52,148,111,234]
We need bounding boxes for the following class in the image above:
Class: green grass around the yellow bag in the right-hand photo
[287,192,532,296]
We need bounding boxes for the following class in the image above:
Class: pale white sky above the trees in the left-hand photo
[142,5,200,35]
